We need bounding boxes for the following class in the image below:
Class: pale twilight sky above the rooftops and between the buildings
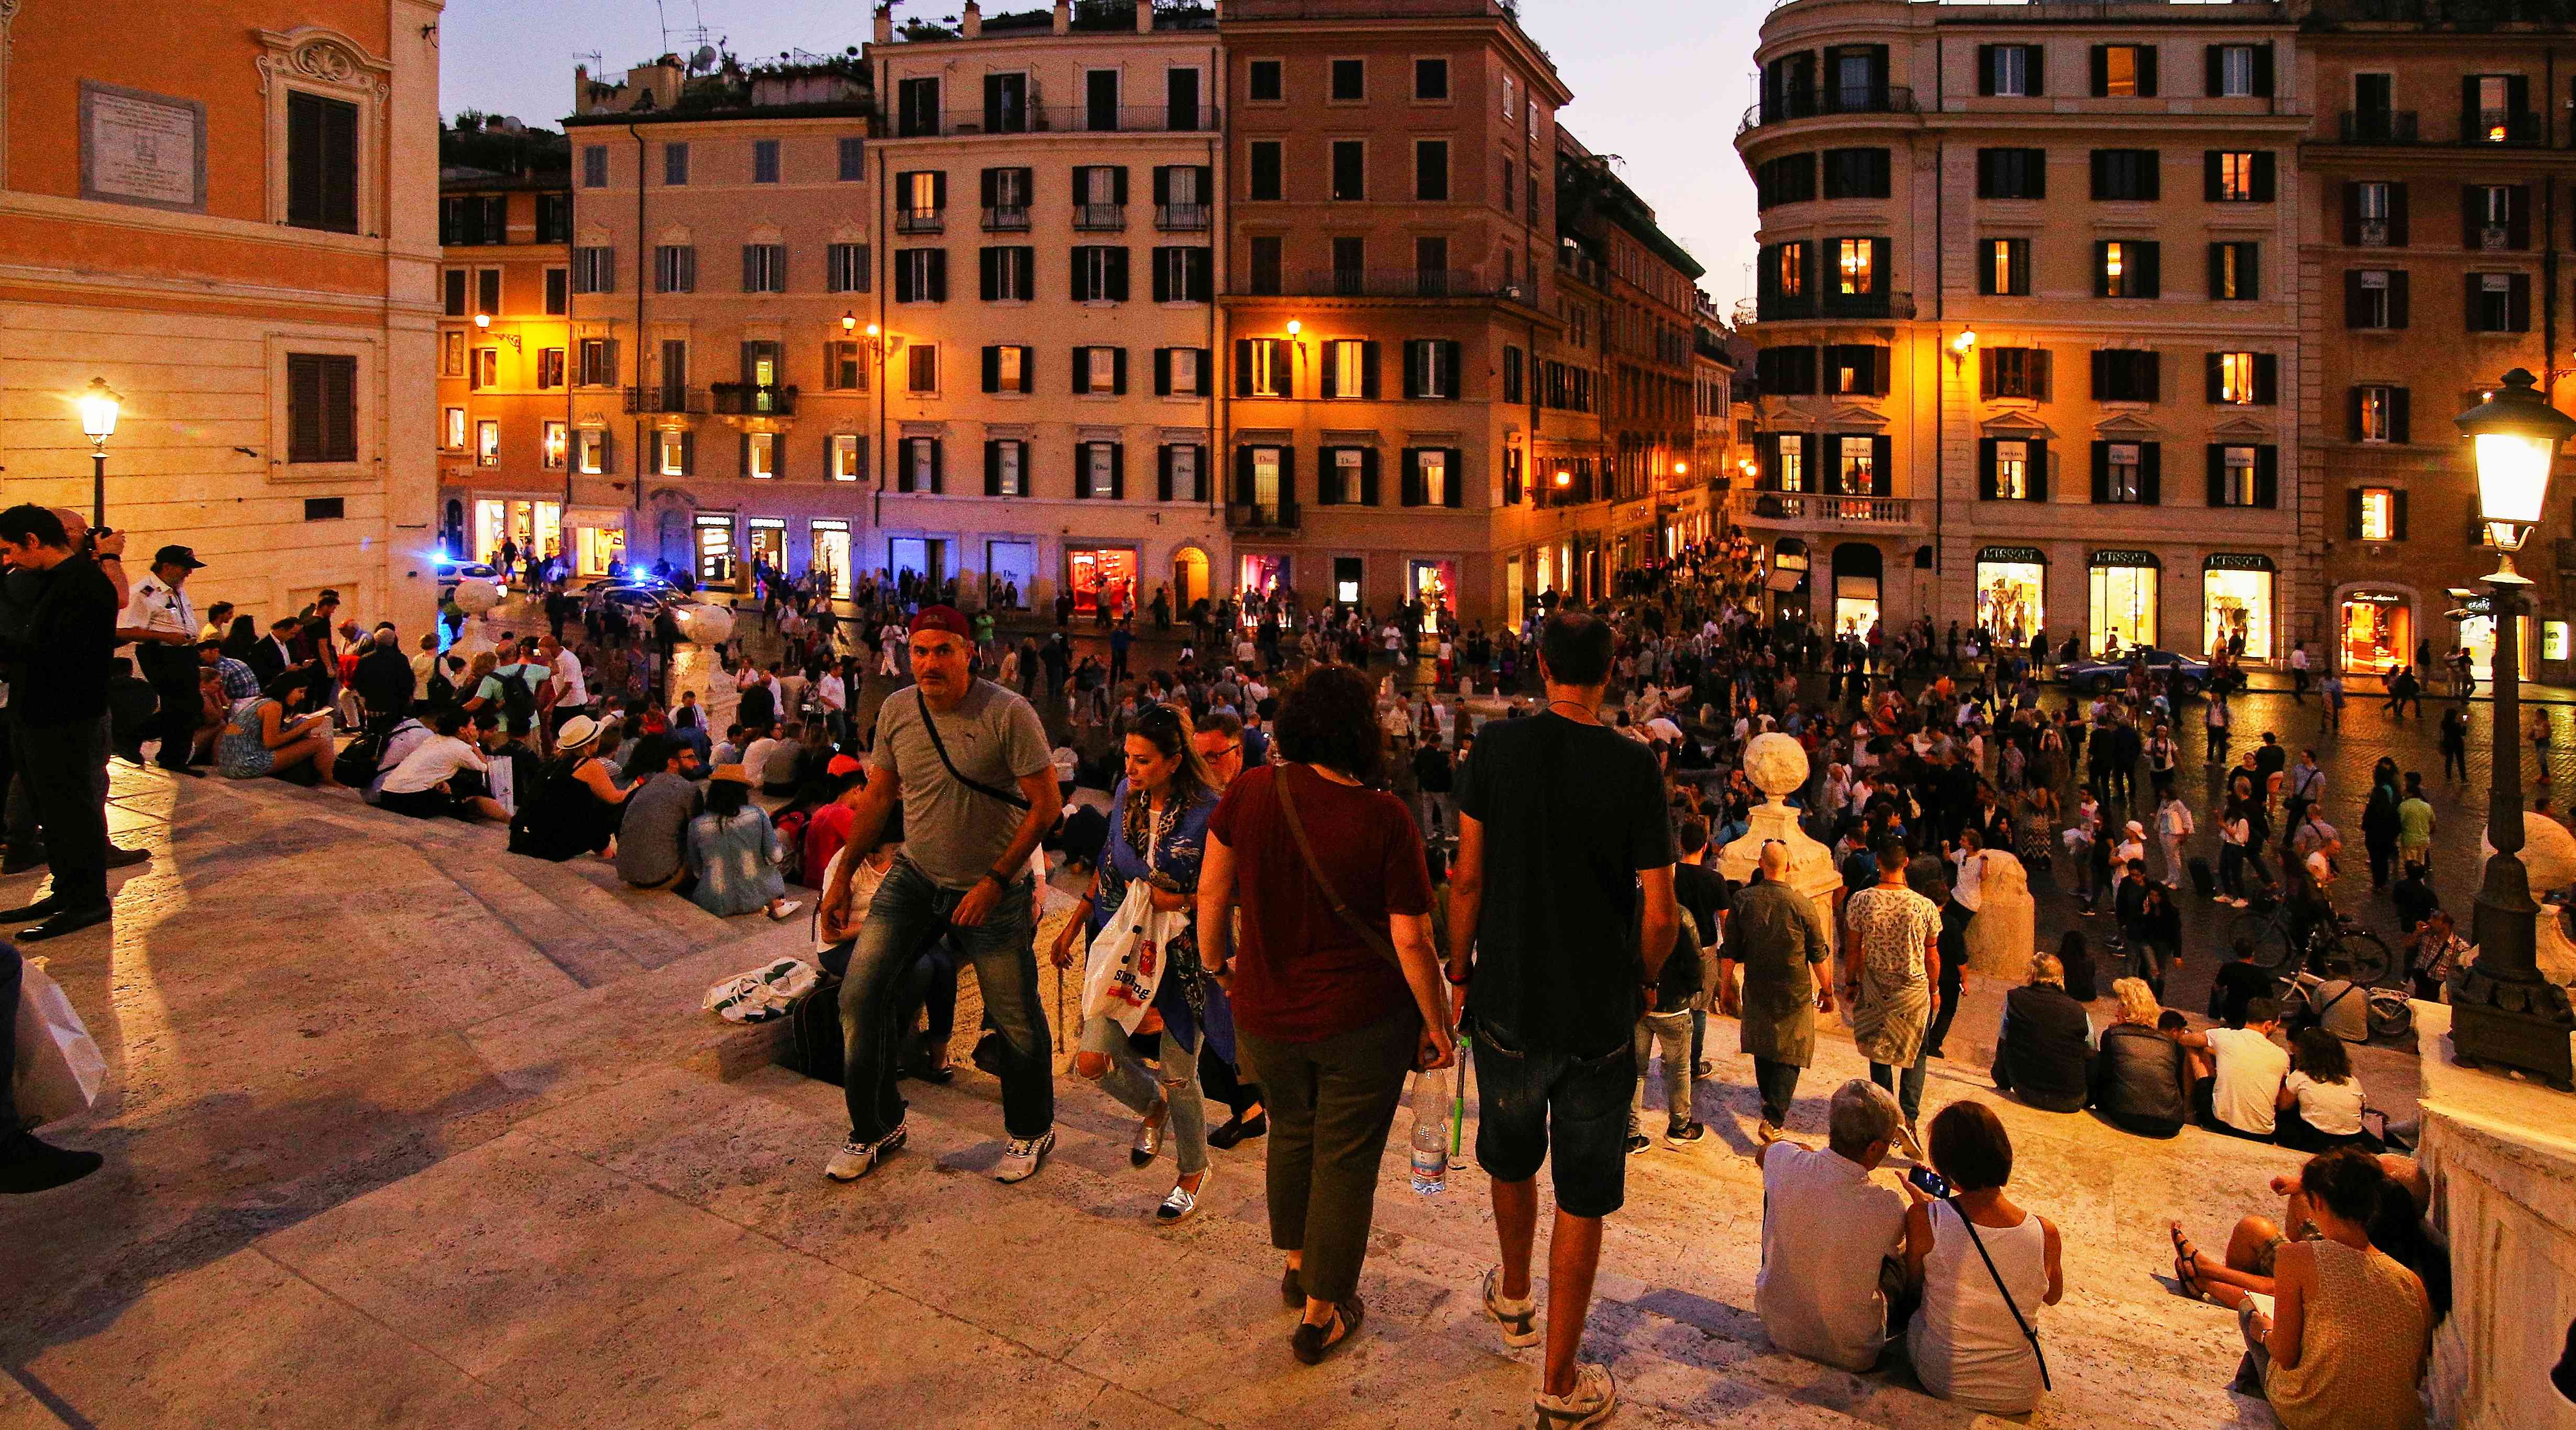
[438,0,1767,312]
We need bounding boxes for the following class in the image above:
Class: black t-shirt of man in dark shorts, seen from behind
[1458,714,1675,1056]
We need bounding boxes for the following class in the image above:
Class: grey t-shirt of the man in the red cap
[873,680,1053,889]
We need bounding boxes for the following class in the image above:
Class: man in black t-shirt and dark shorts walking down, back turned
[1448,613,1682,1422]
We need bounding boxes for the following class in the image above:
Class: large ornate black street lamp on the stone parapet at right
[2450,369,2576,1092]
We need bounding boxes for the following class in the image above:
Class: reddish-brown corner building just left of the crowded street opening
[1221,0,1589,621]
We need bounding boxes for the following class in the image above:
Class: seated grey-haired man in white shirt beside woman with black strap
[1754,1077,1922,1371]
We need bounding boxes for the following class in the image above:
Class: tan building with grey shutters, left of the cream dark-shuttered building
[559,57,884,590]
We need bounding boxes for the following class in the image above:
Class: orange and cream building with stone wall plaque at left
[0,0,438,629]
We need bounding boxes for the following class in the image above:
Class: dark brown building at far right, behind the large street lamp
[2300,0,2576,683]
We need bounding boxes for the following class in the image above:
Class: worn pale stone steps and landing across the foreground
[0,600,2414,1430]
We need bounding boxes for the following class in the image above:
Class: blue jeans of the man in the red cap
[840,856,1056,1141]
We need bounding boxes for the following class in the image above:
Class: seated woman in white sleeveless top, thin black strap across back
[1906,1103,2066,1414]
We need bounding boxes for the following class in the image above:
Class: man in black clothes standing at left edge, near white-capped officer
[0,505,121,940]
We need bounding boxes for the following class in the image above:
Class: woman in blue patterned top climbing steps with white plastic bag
[1051,706,1234,1226]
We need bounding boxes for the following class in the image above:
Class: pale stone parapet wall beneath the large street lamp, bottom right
[2414,1002,2576,1430]
